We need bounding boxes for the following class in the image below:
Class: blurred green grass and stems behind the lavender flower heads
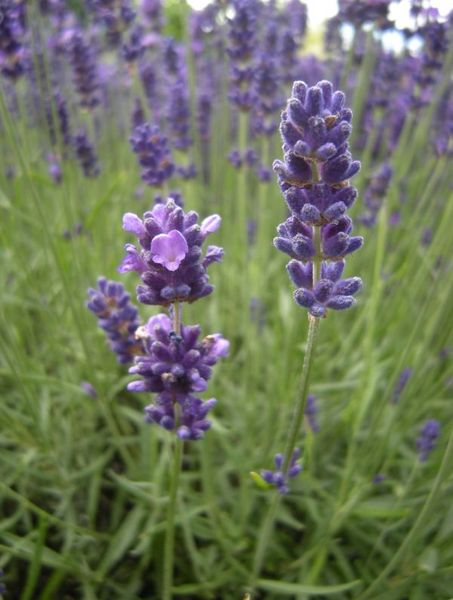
[0,7,453,600]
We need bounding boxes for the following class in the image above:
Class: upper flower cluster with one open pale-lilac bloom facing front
[119,199,223,306]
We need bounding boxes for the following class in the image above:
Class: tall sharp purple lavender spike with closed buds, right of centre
[273,81,363,324]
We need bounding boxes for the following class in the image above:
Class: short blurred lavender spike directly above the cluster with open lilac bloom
[130,123,175,187]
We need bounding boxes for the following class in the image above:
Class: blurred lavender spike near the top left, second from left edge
[68,31,99,109]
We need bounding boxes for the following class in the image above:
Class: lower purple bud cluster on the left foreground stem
[128,314,229,440]
